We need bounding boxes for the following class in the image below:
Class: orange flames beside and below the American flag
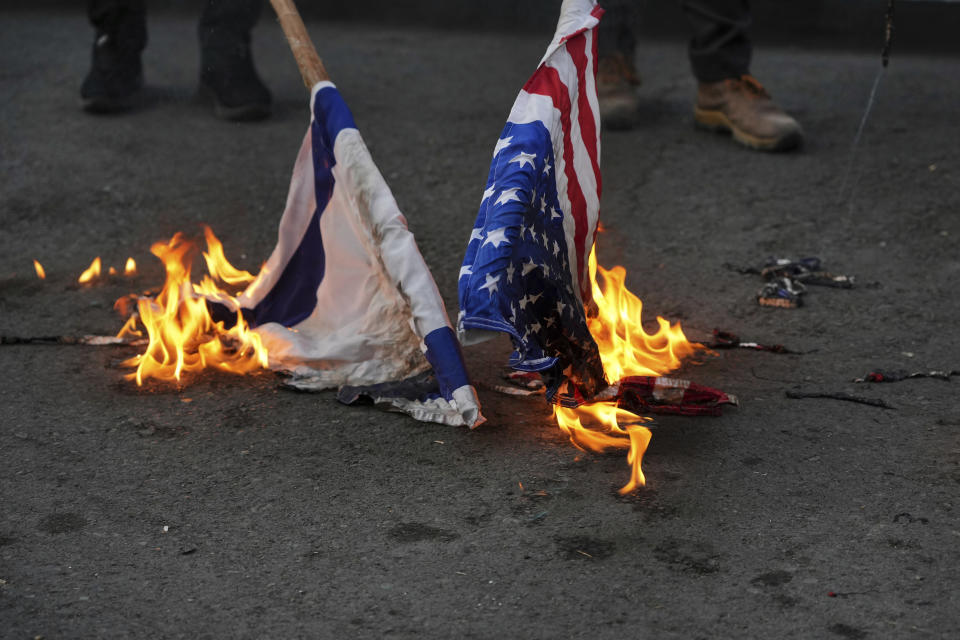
[554,245,699,494]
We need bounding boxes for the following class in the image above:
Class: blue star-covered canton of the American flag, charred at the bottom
[459,123,589,380]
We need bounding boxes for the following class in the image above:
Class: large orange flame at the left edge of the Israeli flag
[117,228,267,385]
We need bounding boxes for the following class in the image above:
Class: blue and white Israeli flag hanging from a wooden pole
[238,82,484,427]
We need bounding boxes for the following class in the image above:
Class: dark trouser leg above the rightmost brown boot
[681,0,753,82]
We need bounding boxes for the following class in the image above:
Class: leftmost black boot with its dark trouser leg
[80,0,147,113]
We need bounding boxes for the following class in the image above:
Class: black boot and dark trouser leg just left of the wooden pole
[199,0,271,120]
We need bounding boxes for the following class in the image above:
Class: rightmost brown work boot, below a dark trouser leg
[693,75,803,151]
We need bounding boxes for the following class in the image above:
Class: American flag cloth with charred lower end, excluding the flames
[458,0,607,404]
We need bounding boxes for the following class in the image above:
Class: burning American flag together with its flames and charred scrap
[458,0,712,493]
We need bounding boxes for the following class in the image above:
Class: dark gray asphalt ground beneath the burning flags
[0,8,960,638]
